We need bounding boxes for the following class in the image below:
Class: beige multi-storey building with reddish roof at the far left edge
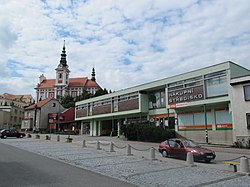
[0,93,34,129]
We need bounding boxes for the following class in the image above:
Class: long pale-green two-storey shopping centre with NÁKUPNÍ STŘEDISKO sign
[75,61,250,145]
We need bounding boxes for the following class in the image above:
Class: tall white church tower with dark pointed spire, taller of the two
[55,40,70,97]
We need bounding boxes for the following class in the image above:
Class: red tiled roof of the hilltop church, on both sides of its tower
[37,77,100,88]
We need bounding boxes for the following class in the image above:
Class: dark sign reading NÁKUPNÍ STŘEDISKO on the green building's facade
[168,86,204,105]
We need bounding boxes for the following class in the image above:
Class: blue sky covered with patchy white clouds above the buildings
[0,0,250,96]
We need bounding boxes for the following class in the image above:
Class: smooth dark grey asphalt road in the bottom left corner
[0,143,139,187]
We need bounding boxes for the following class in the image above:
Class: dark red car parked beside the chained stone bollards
[159,138,215,162]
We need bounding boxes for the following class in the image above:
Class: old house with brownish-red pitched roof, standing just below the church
[21,98,65,131]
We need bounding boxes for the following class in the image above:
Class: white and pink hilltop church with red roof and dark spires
[35,41,101,101]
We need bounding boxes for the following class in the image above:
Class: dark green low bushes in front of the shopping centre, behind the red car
[121,124,176,142]
